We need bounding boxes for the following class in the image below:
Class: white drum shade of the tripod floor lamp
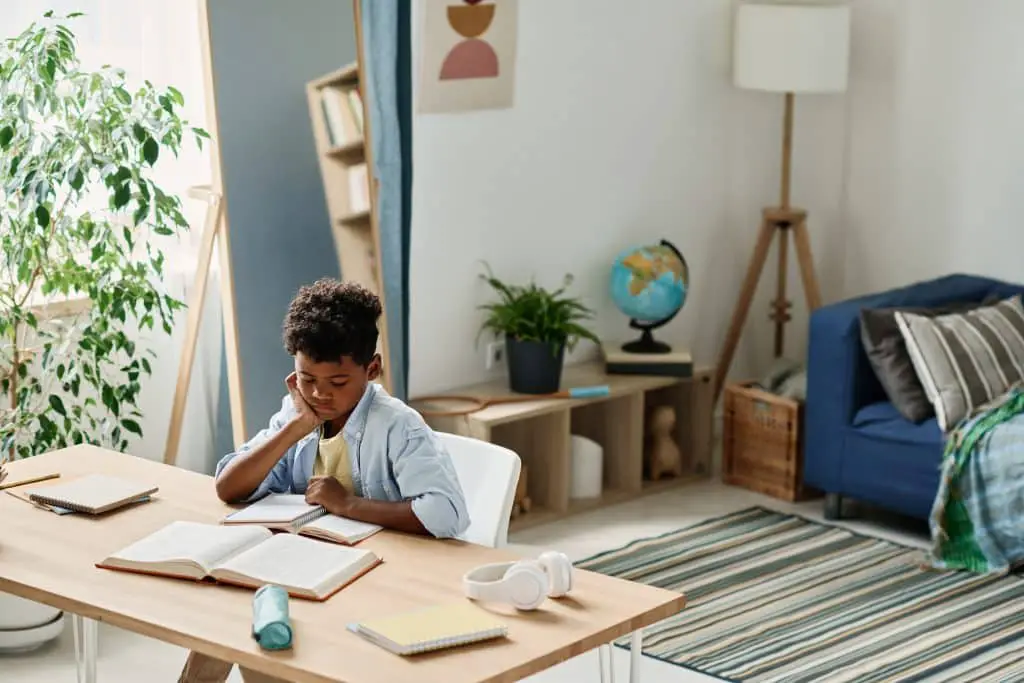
[733,3,850,93]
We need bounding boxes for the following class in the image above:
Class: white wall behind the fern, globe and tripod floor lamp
[411,0,846,396]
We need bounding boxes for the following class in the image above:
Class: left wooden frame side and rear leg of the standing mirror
[164,0,246,465]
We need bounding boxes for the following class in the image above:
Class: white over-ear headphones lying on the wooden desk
[462,551,572,610]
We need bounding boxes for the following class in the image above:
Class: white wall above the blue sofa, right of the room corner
[843,0,1024,294]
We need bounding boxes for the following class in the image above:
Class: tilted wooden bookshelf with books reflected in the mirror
[306,56,391,390]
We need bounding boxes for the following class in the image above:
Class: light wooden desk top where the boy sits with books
[0,446,684,683]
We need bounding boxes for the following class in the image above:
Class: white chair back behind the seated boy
[437,432,521,548]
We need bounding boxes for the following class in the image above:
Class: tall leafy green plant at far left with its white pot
[0,12,208,648]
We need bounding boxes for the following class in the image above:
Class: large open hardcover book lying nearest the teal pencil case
[97,521,381,600]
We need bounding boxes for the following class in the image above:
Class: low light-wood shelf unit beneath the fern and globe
[411,362,714,530]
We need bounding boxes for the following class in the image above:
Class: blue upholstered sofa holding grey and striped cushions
[804,274,1024,519]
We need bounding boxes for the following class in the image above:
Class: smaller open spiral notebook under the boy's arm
[223,494,381,546]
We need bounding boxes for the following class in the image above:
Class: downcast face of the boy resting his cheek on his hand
[295,352,381,422]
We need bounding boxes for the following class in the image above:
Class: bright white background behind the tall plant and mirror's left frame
[0,0,221,470]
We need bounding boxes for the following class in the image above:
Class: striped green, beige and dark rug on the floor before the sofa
[579,508,1024,683]
